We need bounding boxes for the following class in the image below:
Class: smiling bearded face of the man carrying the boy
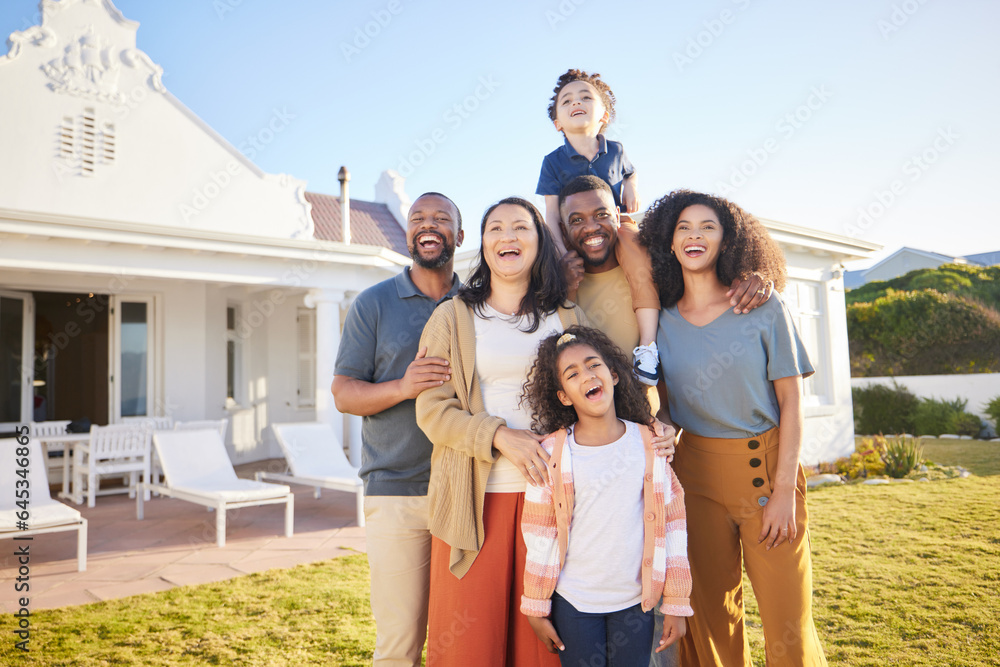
[559,190,619,273]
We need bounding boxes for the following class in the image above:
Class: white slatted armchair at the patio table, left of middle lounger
[73,423,150,507]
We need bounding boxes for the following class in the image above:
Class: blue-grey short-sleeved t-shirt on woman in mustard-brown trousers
[656,294,815,438]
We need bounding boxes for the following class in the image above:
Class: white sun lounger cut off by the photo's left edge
[0,438,87,572]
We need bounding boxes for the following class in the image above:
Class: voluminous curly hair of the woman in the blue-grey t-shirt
[639,190,786,308]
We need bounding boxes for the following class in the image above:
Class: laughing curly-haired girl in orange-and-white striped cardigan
[521,326,692,666]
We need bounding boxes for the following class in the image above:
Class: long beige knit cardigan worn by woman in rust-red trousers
[417,297,587,579]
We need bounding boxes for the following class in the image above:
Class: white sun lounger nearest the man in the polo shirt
[257,422,365,526]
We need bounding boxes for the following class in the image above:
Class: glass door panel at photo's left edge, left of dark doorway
[0,290,34,433]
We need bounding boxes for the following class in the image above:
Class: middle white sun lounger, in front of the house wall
[136,429,295,547]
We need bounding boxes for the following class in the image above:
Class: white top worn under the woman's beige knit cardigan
[475,304,563,493]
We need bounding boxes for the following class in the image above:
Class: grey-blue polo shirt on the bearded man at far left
[333,268,462,496]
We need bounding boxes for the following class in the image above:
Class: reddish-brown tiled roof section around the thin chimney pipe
[306,192,410,257]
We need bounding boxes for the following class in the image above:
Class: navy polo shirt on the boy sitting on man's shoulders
[535,134,635,208]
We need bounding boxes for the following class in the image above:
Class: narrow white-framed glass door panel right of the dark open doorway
[108,296,156,422]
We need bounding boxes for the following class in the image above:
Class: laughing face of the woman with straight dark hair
[482,204,538,280]
